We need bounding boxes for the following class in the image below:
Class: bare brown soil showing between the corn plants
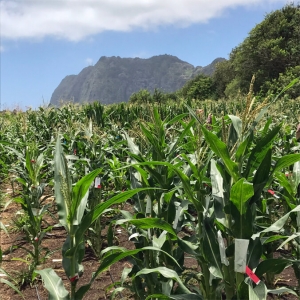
[0,185,298,300]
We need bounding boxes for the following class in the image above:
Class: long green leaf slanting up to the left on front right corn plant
[201,126,238,181]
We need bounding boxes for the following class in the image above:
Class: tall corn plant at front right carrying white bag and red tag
[173,79,300,299]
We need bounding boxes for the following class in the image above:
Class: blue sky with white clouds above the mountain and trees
[0,0,289,109]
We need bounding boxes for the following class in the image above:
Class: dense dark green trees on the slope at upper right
[213,4,300,97]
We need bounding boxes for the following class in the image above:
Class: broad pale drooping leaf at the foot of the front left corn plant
[35,268,70,300]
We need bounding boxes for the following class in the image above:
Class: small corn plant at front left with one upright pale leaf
[35,137,155,300]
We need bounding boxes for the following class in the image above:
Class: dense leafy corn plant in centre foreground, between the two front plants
[110,109,204,299]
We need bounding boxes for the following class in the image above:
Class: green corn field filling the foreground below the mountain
[0,82,300,300]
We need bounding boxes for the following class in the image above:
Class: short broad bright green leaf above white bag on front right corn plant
[230,178,254,215]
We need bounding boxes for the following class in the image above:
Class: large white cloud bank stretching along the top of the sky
[0,0,289,41]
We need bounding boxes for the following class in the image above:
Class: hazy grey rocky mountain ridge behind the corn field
[50,54,224,105]
